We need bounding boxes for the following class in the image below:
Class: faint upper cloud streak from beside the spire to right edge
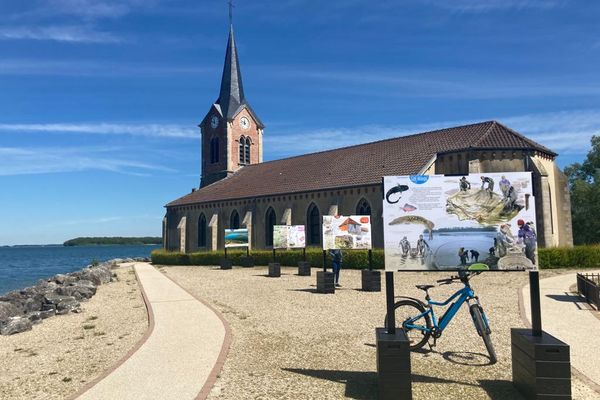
[263,65,600,99]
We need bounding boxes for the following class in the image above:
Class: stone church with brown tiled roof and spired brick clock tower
[163,26,573,252]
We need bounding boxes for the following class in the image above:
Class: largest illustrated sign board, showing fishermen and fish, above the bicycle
[383,172,537,271]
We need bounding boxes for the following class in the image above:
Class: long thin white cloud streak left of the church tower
[0,123,200,139]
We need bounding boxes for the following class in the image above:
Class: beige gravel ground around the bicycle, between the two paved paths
[161,267,600,400]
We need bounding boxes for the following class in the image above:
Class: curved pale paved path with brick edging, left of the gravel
[77,263,229,400]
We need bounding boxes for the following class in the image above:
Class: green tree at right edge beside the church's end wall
[565,136,600,244]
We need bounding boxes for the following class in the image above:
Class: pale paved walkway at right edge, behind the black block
[522,271,600,385]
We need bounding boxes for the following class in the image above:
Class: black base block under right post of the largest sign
[510,328,572,400]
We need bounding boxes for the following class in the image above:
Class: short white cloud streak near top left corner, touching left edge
[0,26,123,43]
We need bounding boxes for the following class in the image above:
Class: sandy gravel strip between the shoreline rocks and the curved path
[0,267,148,400]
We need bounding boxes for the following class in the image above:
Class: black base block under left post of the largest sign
[375,328,412,400]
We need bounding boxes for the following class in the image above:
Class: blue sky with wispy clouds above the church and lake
[0,0,600,245]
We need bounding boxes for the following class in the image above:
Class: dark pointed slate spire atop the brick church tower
[217,25,246,120]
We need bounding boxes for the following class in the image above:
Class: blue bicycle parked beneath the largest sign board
[385,271,497,364]
